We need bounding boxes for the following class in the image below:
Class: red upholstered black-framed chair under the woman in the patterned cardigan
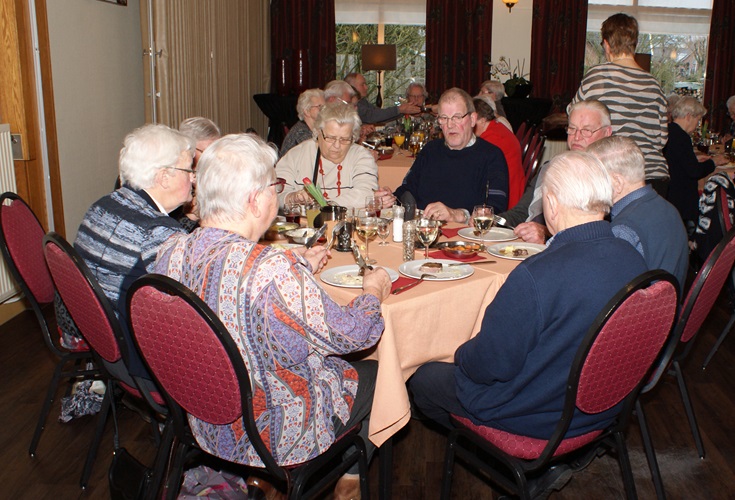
[127,274,370,499]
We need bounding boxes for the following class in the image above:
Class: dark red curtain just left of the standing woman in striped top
[530,0,587,112]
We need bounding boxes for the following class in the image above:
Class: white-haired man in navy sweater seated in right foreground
[408,151,647,498]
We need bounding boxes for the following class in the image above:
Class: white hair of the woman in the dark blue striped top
[118,124,195,189]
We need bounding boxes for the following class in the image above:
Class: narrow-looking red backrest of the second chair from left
[43,232,122,365]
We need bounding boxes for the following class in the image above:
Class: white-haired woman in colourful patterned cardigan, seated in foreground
[156,133,390,498]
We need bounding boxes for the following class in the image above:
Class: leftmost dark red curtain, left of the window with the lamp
[271,0,337,94]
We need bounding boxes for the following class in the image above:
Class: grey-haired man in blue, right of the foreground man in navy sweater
[588,136,689,290]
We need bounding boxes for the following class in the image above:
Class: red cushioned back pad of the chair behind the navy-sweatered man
[577,281,677,413]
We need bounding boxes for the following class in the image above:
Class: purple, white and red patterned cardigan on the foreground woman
[156,228,384,466]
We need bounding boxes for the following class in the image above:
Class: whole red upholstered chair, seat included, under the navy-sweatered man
[441,270,678,499]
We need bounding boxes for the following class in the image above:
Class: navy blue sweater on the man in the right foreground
[455,221,647,439]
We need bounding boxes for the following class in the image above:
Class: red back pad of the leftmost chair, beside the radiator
[0,199,54,304]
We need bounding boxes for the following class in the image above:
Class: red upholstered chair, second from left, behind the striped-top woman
[43,232,170,488]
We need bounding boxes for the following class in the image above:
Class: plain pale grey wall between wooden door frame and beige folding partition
[47,0,145,241]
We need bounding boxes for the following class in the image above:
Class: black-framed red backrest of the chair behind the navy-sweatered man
[538,269,679,461]
